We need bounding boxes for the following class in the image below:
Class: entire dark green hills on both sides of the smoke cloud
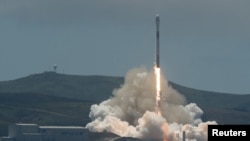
[0,72,250,136]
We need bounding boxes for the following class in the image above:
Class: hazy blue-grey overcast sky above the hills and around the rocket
[0,0,250,94]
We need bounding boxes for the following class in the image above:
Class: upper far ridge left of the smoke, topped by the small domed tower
[0,72,123,101]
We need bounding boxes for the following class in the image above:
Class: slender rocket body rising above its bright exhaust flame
[155,14,160,68]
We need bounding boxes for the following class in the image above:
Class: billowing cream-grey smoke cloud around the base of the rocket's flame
[86,68,217,141]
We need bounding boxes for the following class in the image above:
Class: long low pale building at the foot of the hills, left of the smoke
[0,124,89,141]
